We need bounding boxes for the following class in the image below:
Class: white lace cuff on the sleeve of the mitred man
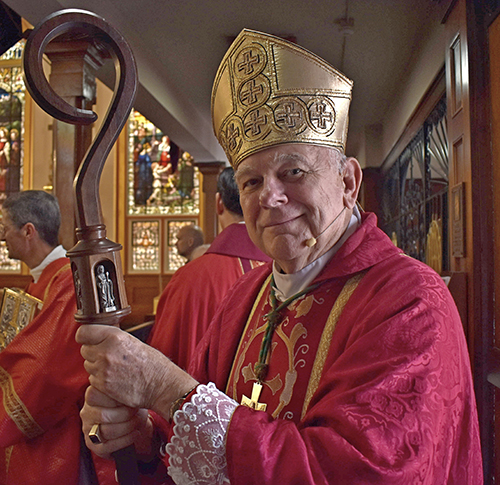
[167,382,238,485]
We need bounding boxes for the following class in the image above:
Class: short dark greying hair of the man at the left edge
[2,190,61,247]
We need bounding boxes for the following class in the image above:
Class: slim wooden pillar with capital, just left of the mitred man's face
[196,162,225,244]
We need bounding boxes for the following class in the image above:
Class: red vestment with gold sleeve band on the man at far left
[0,258,116,485]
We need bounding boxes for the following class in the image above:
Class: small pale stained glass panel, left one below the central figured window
[131,220,161,272]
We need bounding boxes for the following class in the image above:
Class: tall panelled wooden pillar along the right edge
[445,0,500,476]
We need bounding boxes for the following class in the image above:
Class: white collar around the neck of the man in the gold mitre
[273,206,361,301]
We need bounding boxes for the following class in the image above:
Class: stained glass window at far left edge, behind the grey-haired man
[0,40,25,272]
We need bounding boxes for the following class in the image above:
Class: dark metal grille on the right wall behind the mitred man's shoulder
[381,97,449,272]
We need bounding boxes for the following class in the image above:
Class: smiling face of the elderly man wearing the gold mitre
[236,144,357,273]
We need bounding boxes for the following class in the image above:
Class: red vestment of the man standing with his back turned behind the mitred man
[148,224,270,369]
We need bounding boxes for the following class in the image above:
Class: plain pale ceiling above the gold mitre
[4,0,449,161]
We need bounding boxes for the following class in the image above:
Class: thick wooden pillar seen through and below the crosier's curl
[45,39,103,249]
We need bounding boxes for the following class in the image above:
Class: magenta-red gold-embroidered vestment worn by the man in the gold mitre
[177,214,483,485]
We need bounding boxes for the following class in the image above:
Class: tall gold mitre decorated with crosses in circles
[212,29,352,168]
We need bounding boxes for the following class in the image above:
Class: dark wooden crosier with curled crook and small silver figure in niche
[23,9,139,485]
